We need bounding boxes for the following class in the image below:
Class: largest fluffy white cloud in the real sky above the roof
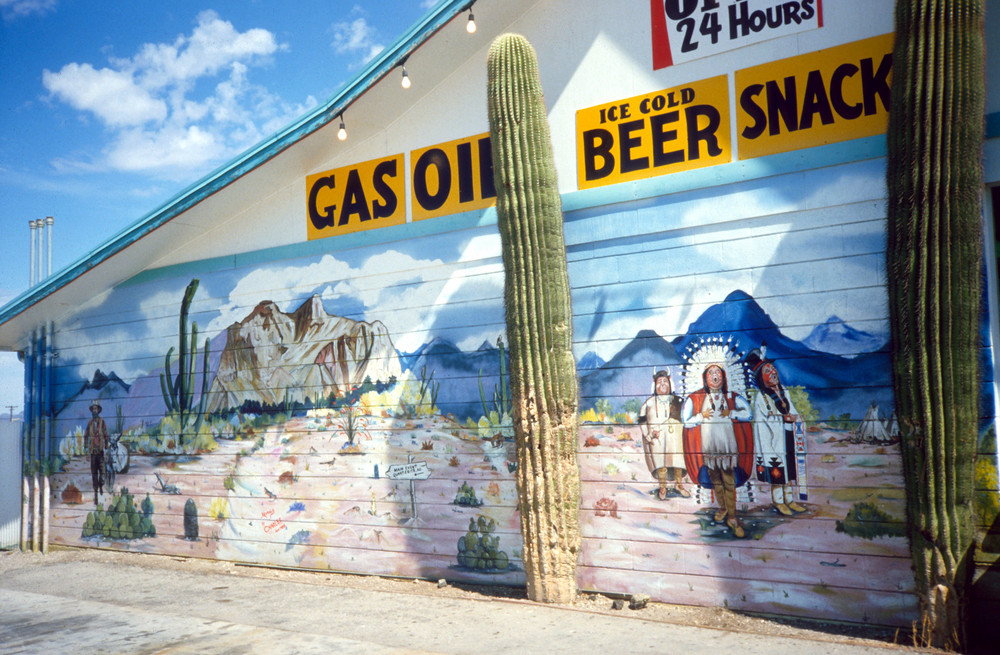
[41,12,316,179]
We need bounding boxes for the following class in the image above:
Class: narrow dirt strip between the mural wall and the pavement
[0,547,913,649]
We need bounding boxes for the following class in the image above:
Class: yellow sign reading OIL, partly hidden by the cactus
[410,134,497,221]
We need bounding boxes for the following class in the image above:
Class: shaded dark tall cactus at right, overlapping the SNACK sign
[886,0,984,647]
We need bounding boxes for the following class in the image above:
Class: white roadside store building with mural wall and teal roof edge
[0,0,1000,626]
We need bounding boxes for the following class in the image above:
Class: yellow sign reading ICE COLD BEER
[576,75,732,189]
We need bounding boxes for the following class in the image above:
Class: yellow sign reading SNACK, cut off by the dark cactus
[736,34,892,159]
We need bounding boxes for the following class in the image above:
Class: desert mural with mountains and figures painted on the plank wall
[45,162,915,625]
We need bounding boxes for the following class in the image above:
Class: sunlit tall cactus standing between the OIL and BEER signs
[487,34,580,603]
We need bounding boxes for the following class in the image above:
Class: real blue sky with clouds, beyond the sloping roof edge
[0,0,436,413]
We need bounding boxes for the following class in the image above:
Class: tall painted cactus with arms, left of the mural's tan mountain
[160,278,210,440]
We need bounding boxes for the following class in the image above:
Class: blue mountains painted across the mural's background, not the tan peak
[59,290,892,428]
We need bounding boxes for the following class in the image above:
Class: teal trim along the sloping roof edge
[0,0,474,324]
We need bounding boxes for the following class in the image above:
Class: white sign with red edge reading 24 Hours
[649,0,823,70]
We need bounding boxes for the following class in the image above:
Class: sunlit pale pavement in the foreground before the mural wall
[0,560,920,655]
